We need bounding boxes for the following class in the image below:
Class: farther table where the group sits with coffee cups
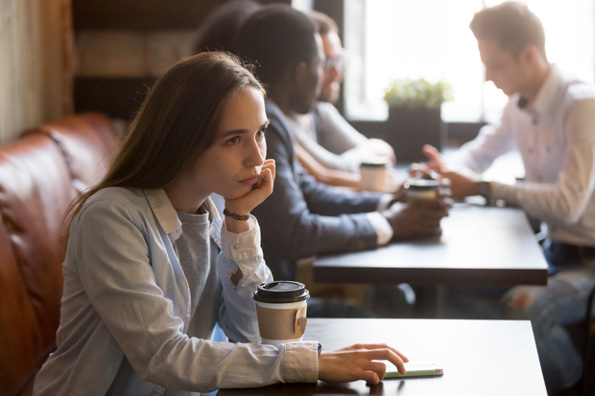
[313,204,547,286]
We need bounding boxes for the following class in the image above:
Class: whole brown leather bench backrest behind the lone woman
[0,113,119,396]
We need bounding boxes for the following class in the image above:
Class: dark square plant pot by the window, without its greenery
[385,107,447,164]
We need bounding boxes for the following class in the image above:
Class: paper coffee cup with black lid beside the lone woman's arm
[254,281,310,346]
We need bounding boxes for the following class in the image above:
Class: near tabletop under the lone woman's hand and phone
[217,319,547,396]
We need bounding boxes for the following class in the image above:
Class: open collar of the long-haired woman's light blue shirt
[143,189,220,239]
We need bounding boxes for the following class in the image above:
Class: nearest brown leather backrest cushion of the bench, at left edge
[0,134,77,395]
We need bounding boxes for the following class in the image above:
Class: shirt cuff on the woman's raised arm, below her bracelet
[221,215,262,263]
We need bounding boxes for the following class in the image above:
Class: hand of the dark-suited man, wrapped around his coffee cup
[381,200,449,241]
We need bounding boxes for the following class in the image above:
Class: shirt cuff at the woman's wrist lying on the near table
[283,341,318,382]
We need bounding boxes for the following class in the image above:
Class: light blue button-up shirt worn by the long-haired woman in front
[34,188,318,396]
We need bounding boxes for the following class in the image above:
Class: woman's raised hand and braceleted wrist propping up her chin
[225,159,275,233]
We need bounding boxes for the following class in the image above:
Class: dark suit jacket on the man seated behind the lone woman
[253,115,379,270]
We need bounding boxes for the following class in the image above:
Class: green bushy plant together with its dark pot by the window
[384,78,452,162]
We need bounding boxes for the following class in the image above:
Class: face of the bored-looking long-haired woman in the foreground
[188,88,269,203]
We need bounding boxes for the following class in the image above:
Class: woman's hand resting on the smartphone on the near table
[318,344,409,385]
